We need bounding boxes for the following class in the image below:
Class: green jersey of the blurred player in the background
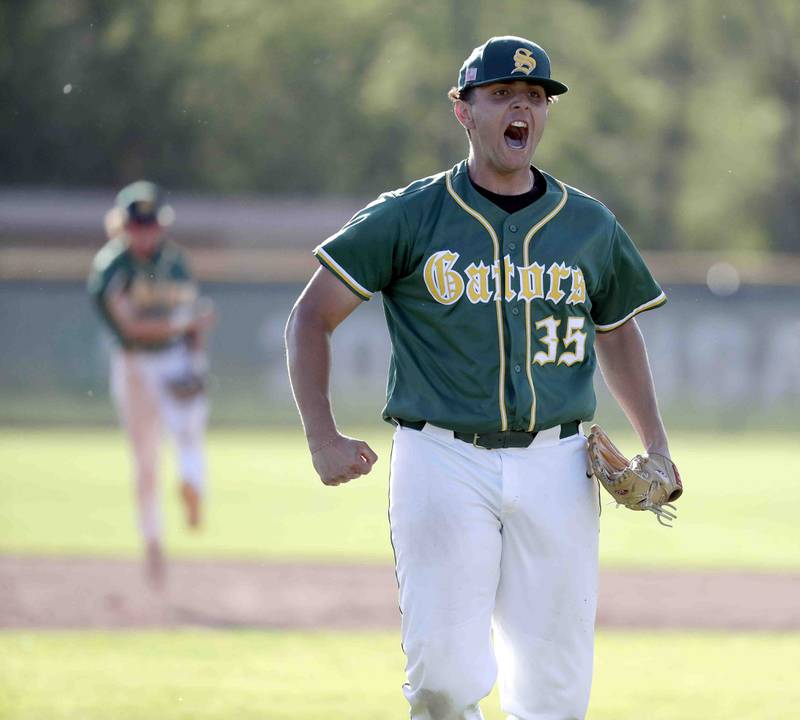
[88,237,197,350]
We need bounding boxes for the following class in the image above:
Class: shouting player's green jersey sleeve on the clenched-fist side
[314,193,409,300]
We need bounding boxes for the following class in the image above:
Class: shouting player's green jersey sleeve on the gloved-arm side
[591,222,667,332]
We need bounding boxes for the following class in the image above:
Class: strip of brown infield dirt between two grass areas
[0,555,800,630]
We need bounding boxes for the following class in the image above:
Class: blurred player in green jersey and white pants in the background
[88,181,214,586]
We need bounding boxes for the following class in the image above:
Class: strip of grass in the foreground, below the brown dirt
[0,631,800,720]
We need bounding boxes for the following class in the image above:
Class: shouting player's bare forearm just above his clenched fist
[286,304,338,449]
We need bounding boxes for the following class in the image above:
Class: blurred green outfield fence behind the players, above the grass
[0,272,800,429]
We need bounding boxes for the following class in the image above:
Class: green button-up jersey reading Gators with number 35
[314,161,666,433]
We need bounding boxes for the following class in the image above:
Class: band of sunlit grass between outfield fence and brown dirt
[0,426,800,569]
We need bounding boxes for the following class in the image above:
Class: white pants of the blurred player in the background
[111,344,208,540]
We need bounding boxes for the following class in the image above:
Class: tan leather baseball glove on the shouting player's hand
[588,425,683,527]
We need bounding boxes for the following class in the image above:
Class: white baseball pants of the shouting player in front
[389,425,600,720]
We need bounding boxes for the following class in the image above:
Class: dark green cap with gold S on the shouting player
[458,35,569,95]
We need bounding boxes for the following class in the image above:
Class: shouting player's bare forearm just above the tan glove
[595,320,669,455]
